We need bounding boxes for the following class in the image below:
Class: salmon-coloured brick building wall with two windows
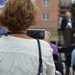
[31,0,58,35]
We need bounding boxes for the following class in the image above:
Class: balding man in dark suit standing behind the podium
[61,12,75,31]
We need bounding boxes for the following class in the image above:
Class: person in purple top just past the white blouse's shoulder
[44,31,58,54]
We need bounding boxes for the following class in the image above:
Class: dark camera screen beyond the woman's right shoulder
[27,29,45,39]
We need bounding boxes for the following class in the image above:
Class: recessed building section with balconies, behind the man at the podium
[58,0,72,29]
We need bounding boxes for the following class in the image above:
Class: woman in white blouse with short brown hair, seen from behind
[0,0,55,75]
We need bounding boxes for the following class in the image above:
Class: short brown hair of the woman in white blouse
[0,0,38,32]
